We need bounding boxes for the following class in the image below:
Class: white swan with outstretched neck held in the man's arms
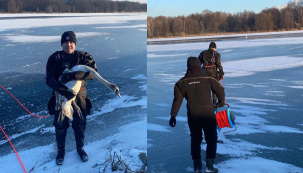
[55,65,121,121]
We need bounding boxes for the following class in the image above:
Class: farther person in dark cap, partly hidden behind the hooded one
[199,42,224,107]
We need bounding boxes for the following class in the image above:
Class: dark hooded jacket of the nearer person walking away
[171,57,225,118]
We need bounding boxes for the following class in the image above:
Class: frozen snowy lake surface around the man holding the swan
[0,13,147,173]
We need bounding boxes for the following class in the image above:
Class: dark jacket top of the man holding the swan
[46,50,97,115]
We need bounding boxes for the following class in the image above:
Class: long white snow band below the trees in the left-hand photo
[0,13,147,31]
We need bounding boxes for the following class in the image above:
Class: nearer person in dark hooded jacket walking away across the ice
[169,57,225,172]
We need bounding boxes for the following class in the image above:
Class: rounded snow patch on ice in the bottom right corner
[218,157,303,173]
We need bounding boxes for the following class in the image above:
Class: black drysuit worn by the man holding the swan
[46,51,97,151]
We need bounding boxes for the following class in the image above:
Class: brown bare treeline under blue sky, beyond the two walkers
[147,0,303,38]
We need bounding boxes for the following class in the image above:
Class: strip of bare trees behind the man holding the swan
[0,0,147,13]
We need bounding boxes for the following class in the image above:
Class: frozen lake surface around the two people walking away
[147,31,303,173]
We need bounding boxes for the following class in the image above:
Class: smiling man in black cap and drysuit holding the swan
[46,31,97,165]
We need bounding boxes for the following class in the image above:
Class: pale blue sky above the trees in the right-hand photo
[147,0,294,17]
